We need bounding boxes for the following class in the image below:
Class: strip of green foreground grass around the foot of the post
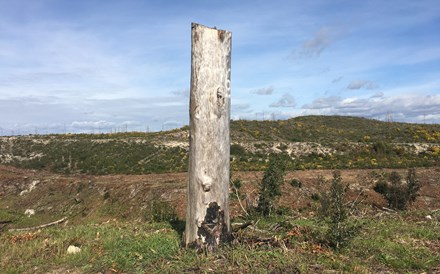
[0,212,440,273]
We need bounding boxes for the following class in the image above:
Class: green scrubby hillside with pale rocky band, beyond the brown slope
[0,116,440,174]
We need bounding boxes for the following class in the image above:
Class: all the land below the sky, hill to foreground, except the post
[0,116,440,273]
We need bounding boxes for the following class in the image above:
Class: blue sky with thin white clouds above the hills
[0,0,440,135]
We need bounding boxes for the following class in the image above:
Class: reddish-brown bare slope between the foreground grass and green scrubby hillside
[0,165,440,227]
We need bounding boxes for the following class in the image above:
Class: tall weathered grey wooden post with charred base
[184,23,232,250]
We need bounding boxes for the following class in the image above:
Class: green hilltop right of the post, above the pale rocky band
[231,116,440,143]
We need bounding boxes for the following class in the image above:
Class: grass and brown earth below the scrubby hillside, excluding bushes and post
[0,166,440,273]
